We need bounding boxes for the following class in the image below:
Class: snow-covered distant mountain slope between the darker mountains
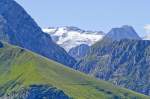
[43,26,105,52]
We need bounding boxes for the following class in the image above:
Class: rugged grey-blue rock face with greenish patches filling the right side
[74,40,150,95]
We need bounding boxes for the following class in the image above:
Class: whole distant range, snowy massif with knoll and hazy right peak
[43,25,144,60]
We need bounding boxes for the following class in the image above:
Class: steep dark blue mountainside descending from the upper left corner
[0,0,76,66]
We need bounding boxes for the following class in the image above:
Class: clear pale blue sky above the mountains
[16,0,150,35]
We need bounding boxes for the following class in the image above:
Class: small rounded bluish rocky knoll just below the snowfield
[68,44,90,60]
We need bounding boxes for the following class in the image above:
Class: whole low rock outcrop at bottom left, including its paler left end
[0,85,71,99]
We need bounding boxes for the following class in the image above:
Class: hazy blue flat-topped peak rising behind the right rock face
[105,25,141,41]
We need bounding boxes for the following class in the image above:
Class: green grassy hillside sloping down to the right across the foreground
[0,41,150,99]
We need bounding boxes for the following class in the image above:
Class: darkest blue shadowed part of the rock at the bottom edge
[26,85,70,99]
